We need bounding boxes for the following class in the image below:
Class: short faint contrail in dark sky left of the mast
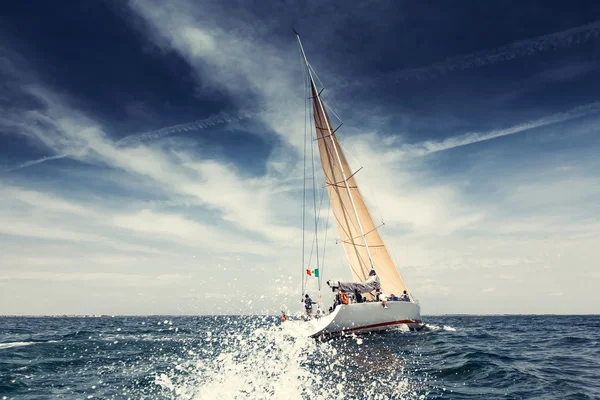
[116,111,258,146]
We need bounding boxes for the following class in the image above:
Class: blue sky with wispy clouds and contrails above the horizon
[0,0,600,315]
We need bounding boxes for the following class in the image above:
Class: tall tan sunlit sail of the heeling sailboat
[311,83,408,295]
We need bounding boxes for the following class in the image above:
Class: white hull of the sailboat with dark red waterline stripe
[309,301,423,337]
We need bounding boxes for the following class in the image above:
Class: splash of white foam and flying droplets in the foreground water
[154,320,418,400]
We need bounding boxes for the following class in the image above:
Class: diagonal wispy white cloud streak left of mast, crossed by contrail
[1,87,294,245]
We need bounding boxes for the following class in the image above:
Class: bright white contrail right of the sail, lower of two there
[400,101,600,156]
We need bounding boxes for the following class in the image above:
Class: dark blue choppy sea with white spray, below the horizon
[0,316,600,400]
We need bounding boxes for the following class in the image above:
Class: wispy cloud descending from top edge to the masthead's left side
[130,0,304,154]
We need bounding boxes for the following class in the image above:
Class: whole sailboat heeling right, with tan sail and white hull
[294,30,424,337]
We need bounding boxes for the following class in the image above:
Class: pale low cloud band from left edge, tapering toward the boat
[0,179,276,262]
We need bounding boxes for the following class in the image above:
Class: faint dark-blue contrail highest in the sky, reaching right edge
[338,21,600,87]
